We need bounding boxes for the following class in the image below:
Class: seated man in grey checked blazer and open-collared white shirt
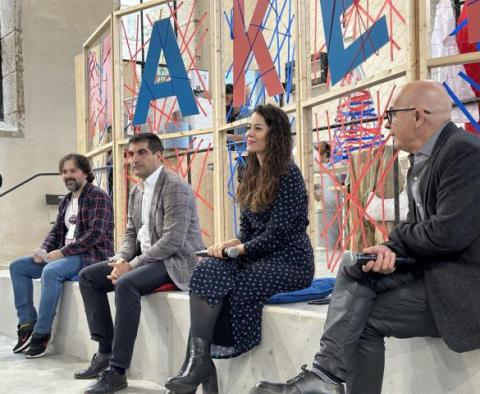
[75,133,204,394]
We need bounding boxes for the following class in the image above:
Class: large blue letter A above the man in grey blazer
[133,18,198,125]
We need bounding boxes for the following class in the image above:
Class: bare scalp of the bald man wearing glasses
[398,81,452,127]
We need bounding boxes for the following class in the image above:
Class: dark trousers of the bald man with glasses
[313,264,439,394]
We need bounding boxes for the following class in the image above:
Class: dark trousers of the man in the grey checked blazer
[79,262,171,369]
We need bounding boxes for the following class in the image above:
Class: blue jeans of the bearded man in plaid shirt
[10,256,83,334]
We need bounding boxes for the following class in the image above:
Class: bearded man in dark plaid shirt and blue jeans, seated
[10,153,113,358]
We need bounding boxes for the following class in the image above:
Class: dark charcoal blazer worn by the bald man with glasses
[386,122,480,352]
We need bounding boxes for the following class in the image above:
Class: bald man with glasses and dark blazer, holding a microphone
[251,81,480,394]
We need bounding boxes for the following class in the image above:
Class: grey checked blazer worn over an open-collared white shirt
[115,168,204,290]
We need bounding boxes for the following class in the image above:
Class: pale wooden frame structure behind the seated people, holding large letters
[76,0,480,268]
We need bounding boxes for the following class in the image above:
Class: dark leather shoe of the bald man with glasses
[250,365,345,394]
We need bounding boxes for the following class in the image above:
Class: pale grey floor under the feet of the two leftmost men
[0,335,165,394]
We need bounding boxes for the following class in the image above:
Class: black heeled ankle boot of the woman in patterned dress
[165,338,218,394]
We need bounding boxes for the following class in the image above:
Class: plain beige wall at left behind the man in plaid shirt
[0,0,116,264]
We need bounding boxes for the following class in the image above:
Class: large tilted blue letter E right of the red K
[320,0,389,85]
